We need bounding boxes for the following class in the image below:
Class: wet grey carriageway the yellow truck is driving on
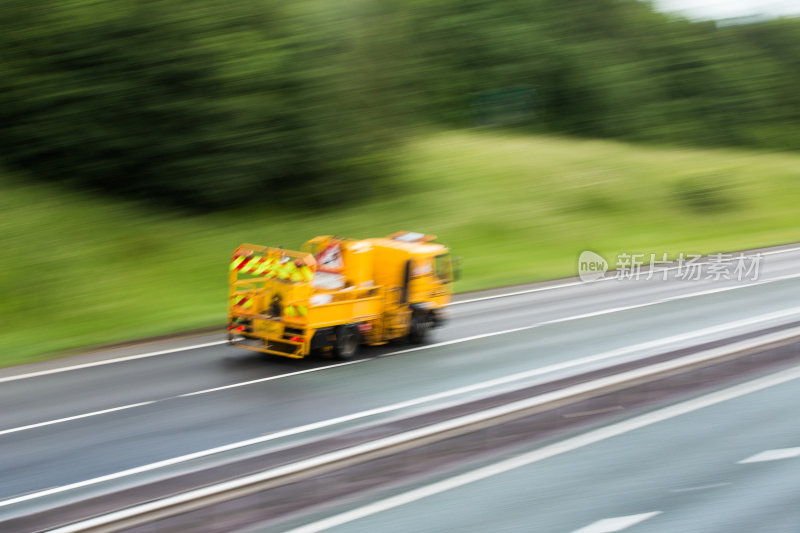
[0,247,800,520]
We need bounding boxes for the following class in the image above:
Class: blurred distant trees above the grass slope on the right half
[398,0,800,145]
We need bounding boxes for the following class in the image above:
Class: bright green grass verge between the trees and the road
[0,132,800,365]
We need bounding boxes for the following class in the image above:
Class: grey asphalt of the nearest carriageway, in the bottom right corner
[272,364,800,533]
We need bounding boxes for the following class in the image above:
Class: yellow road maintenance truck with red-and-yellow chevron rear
[228,232,454,359]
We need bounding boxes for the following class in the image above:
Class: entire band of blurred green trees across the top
[0,0,800,207]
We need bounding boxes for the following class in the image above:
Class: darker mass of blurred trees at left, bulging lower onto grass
[0,0,398,206]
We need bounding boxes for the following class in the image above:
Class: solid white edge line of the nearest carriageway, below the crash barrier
[284,366,800,533]
